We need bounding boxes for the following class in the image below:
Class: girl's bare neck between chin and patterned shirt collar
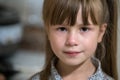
[56,59,95,80]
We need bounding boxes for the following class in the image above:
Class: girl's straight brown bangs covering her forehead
[43,0,102,26]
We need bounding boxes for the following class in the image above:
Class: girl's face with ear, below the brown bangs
[48,8,106,65]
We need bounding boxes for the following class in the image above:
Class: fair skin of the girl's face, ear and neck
[48,8,106,80]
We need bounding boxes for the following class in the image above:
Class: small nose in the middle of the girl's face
[66,33,79,46]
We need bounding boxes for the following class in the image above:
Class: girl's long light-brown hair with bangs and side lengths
[40,0,118,80]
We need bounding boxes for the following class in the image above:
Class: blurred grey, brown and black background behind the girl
[0,0,120,80]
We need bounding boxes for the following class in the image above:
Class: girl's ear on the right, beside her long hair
[98,23,107,43]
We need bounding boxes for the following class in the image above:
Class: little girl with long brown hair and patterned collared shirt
[30,0,117,80]
